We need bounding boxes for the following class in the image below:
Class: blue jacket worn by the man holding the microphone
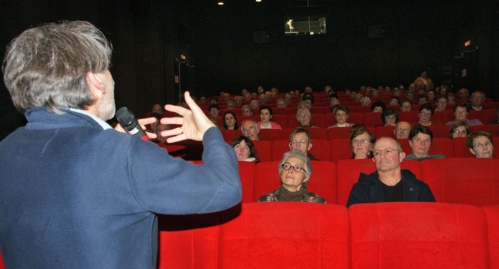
[0,108,241,269]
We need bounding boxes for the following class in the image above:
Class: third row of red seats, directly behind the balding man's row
[159,136,499,162]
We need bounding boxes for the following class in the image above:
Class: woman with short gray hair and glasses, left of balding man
[258,150,326,204]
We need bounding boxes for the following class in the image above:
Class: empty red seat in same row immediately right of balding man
[422,158,499,206]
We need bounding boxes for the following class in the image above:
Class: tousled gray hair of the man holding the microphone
[2,21,112,114]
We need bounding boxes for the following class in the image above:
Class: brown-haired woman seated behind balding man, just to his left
[350,124,375,159]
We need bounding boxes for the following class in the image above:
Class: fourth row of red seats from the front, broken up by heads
[220,124,499,142]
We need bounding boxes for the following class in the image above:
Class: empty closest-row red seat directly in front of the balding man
[349,202,488,269]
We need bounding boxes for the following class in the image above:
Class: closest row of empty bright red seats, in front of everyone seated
[158,202,499,269]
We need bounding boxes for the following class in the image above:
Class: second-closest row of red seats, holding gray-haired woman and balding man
[234,158,499,203]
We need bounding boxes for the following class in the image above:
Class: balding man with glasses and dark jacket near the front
[347,136,435,207]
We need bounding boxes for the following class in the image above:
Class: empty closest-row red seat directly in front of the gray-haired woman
[219,202,350,269]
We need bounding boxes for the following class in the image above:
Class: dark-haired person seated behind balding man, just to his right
[405,125,445,160]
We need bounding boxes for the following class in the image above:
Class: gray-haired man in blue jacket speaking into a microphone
[0,21,241,268]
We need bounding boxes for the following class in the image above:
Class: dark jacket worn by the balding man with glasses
[347,170,435,207]
